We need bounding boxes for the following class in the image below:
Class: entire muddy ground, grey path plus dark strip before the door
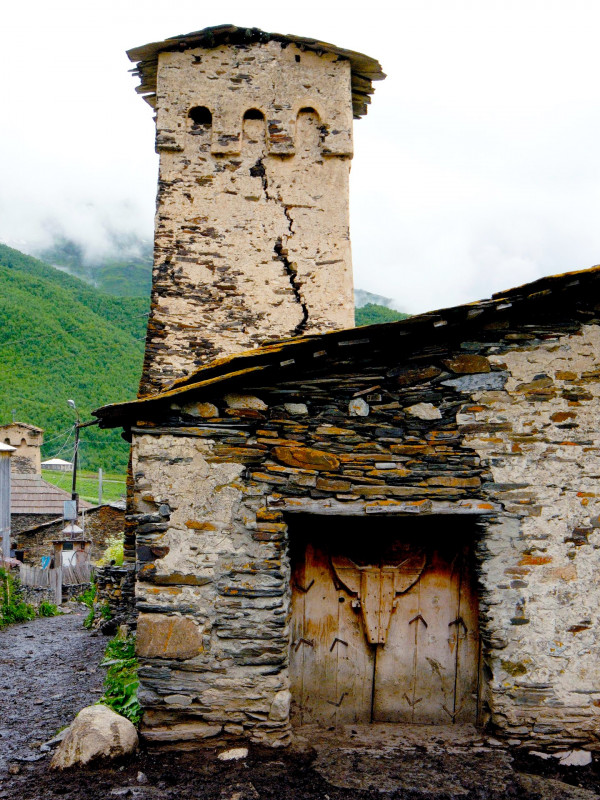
[0,607,600,800]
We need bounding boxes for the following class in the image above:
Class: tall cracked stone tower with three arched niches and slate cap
[128,25,384,394]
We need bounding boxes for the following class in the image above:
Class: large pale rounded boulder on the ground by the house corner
[50,705,138,769]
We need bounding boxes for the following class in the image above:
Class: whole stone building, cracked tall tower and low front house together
[95,26,600,749]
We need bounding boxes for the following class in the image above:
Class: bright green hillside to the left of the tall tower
[0,245,149,471]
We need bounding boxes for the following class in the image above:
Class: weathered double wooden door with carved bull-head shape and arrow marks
[290,529,480,726]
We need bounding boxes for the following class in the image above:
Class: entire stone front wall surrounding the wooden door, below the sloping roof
[129,318,600,747]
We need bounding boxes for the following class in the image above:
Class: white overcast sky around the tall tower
[0,0,600,312]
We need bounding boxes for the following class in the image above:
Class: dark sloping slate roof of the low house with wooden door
[92,266,600,428]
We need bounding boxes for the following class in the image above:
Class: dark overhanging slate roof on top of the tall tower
[127,25,385,119]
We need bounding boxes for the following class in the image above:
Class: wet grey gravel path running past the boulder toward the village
[0,607,106,772]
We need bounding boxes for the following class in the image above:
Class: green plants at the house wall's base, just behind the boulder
[98,634,142,725]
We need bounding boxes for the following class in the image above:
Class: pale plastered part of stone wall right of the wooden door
[458,326,600,745]
